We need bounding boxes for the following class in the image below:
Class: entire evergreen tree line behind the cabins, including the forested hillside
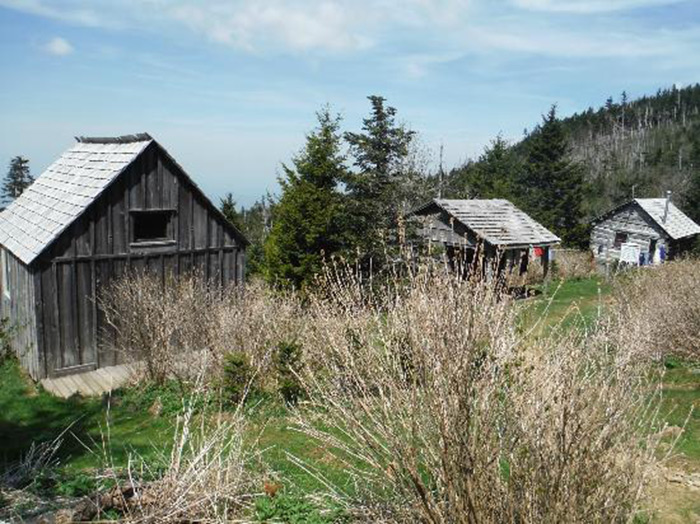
[13,85,700,288]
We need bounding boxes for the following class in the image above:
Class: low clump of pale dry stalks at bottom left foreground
[101,382,259,523]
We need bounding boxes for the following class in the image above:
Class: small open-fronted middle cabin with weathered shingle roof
[409,199,560,275]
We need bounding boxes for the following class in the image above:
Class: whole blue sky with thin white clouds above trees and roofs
[0,0,700,204]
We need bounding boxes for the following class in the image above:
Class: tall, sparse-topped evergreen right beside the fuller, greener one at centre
[345,96,415,258]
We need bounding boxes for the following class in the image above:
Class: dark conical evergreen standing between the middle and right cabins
[520,105,587,247]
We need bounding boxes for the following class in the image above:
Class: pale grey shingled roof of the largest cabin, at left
[0,133,248,265]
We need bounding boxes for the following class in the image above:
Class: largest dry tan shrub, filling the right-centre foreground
[297,270,656,523]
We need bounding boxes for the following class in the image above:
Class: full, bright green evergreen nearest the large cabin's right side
[265,108,346,288]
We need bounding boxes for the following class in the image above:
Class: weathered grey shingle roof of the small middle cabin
[410,198,561,247]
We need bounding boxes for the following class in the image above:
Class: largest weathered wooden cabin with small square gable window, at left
[0,134,248,379]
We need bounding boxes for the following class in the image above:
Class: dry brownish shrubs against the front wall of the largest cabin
[100,272,301,383]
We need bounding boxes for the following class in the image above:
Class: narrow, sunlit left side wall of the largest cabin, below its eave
[0,247,44,379]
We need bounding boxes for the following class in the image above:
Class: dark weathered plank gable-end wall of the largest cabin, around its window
[37,144,244,376]
